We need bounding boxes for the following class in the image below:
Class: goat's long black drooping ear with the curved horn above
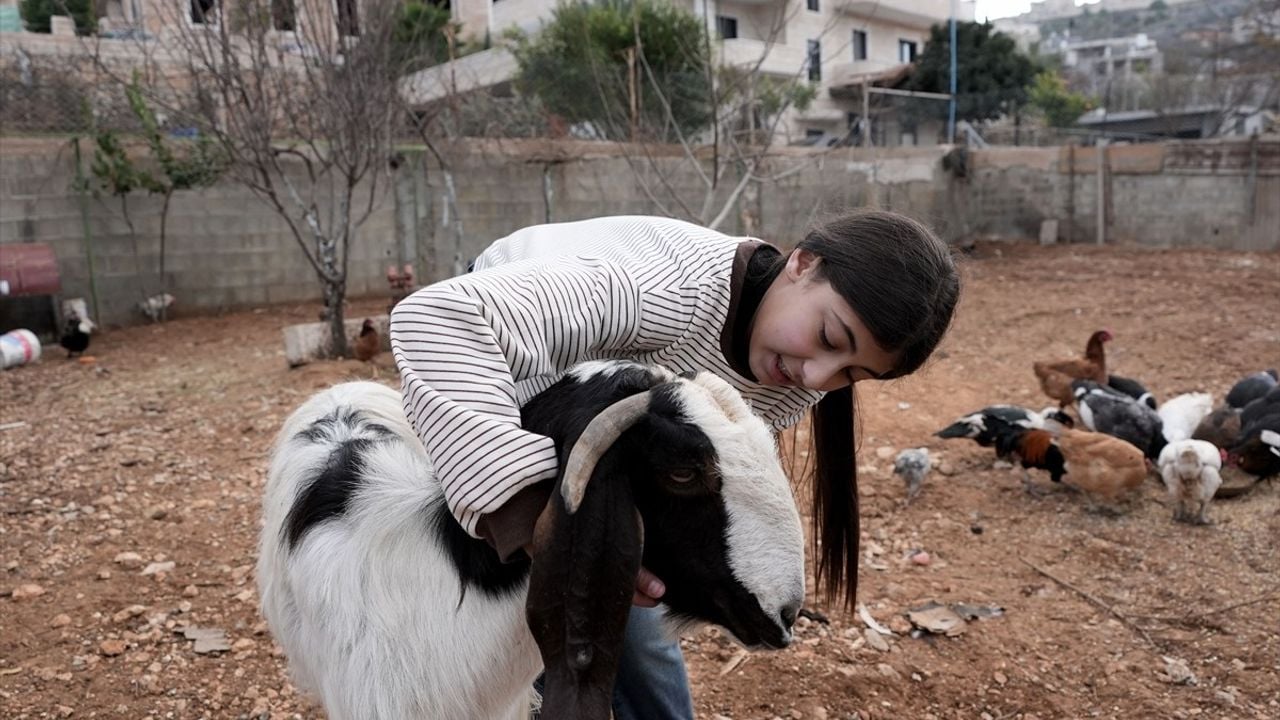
[526,393,649,720]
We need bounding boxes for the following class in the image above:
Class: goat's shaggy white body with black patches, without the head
[257,382,540,720]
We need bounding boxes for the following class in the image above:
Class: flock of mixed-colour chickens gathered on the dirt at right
[893,331,1280,524]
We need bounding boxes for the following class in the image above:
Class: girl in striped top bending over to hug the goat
[390,210,960,720]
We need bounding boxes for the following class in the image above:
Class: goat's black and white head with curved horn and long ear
[525,363,804,717]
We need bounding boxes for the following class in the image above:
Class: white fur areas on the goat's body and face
[257,368,804,720]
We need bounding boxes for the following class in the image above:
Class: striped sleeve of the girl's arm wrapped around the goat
[390,258,665,536]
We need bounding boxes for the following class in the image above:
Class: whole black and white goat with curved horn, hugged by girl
[257,361,804,720]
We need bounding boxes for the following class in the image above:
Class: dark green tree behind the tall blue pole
[906,22,1037,120]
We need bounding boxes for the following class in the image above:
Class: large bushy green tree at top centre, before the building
[515,0,713,141]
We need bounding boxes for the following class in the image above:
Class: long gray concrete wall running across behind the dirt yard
[0,137,1280,324]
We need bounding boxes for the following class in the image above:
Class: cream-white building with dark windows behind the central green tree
[407,0,974,145]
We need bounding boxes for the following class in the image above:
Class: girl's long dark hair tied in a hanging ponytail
[797,210,960,609]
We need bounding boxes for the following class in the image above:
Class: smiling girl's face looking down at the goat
[748,250,897,392]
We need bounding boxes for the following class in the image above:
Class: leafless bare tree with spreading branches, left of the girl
[88,0,416,356]
